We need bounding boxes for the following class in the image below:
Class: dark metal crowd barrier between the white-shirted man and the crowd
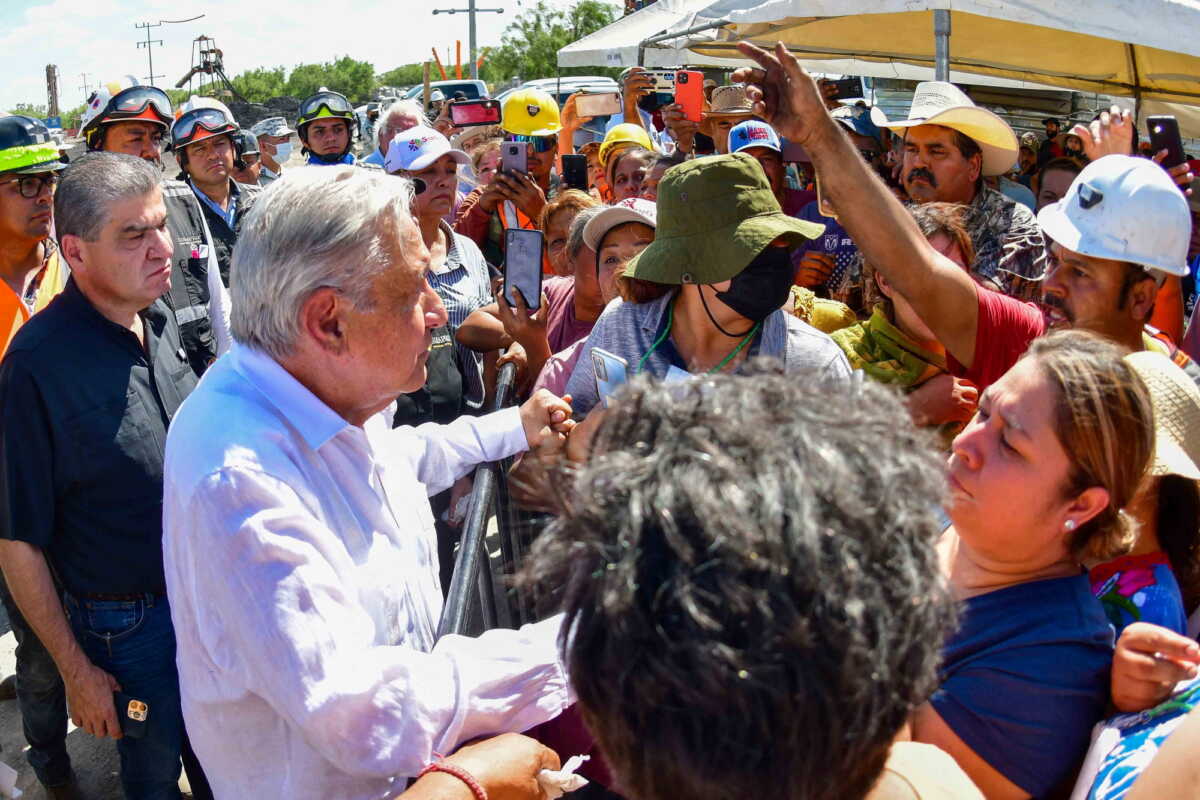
[438,362,517,638]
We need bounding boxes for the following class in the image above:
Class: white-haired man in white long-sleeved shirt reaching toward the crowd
[163,167,570,800]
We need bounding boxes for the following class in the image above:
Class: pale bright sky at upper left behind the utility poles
[0,0,616,109]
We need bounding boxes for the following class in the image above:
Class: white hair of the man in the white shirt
[229,167,414,359]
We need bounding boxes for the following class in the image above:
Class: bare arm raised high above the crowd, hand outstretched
[733,42,979,367]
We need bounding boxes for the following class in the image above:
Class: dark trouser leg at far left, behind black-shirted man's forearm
[0,578,71,786]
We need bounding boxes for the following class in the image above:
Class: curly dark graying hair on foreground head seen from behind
[523,362,954,800]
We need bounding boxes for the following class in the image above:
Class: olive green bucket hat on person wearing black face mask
[625,152,824,285]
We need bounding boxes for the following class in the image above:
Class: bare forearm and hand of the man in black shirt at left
[0,540,121,739]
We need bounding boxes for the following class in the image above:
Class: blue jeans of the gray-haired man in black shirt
[62,595,185,800]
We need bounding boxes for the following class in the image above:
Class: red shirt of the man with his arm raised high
[946,287,1046,392]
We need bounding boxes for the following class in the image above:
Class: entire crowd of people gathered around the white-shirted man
[0,38,1200,800]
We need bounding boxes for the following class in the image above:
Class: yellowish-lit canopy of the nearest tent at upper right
[676,0,1200,104]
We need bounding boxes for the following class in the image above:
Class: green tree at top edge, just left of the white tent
[480,0,620,84]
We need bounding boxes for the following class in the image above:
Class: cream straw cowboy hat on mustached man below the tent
[886,80,1019,175]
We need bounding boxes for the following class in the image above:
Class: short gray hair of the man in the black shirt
[54,152,162,243]
